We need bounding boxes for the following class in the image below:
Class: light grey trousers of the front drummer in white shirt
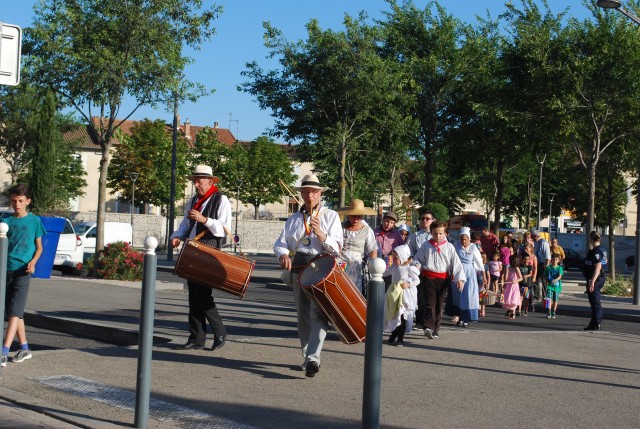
[287,273,329,365]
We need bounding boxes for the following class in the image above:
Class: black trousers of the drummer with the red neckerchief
[187,281,226,346]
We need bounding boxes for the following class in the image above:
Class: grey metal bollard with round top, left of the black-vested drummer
[134,237,158,428]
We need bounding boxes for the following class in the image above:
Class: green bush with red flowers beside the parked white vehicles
[83,241,144,281]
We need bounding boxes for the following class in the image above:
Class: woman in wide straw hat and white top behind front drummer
[338,199,378,295]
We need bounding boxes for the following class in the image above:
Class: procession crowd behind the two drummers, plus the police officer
[337,200,606,346]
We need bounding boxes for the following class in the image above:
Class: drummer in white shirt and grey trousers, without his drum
[273,174,342,377]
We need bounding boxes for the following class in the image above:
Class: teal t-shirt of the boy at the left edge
[2,213,47,271]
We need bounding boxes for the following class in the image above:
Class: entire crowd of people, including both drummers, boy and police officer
[0,165,606,377]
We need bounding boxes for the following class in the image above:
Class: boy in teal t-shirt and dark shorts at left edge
[0,185,46,368]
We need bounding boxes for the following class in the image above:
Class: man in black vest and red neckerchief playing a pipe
[170,165,231,350]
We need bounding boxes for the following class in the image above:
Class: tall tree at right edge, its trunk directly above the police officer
[552,3,640,246]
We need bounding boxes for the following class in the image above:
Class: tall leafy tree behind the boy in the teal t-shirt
[25,0,221,258]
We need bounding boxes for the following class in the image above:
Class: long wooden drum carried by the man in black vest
[173,240,256,299]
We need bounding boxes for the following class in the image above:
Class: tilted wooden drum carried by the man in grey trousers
[298,255,367,344]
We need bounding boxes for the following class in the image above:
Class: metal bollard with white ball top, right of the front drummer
[362,258,387,429]
